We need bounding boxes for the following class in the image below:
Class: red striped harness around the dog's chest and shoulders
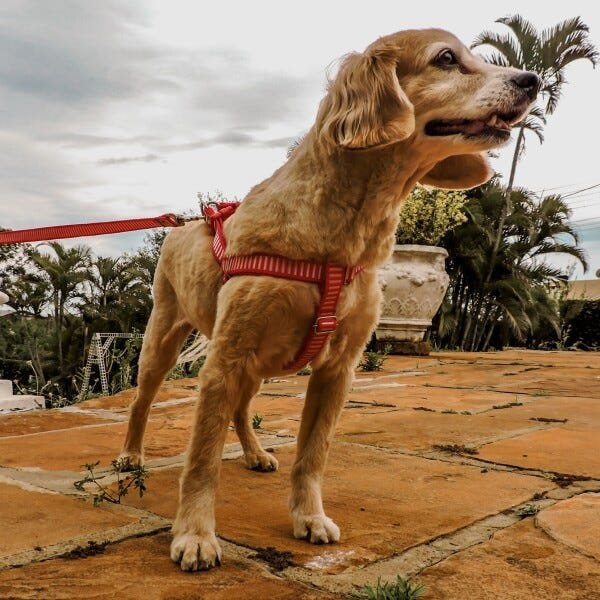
[203,202,363,371]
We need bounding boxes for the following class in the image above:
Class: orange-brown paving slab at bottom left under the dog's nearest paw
[0,534,337,600]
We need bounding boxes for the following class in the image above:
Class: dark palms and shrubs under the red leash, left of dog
[0,231,164,402]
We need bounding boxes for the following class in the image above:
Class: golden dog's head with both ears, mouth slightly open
[317,29,540,188]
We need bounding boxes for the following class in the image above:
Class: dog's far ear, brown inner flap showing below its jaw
[420,152,494,190]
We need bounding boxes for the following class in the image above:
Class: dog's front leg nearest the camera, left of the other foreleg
[171,356,256,571]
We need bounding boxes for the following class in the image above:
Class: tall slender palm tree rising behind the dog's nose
[471,15,599,281]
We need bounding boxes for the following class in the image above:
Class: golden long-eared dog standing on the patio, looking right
[120,29,540,571]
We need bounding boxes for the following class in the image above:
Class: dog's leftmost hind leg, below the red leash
[119,267,192,468]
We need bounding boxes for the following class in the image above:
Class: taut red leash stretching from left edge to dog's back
[0,213,185,246]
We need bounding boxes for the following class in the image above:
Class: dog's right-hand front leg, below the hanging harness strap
[290,356,354,544]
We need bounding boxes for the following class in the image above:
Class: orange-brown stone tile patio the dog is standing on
[0,350,600,600]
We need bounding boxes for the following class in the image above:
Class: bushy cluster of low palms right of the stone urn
[434,180,587,350]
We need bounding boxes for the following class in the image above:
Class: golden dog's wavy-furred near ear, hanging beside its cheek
[317,47,415,148]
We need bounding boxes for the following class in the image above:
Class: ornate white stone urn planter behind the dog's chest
[377,244,449,342]
